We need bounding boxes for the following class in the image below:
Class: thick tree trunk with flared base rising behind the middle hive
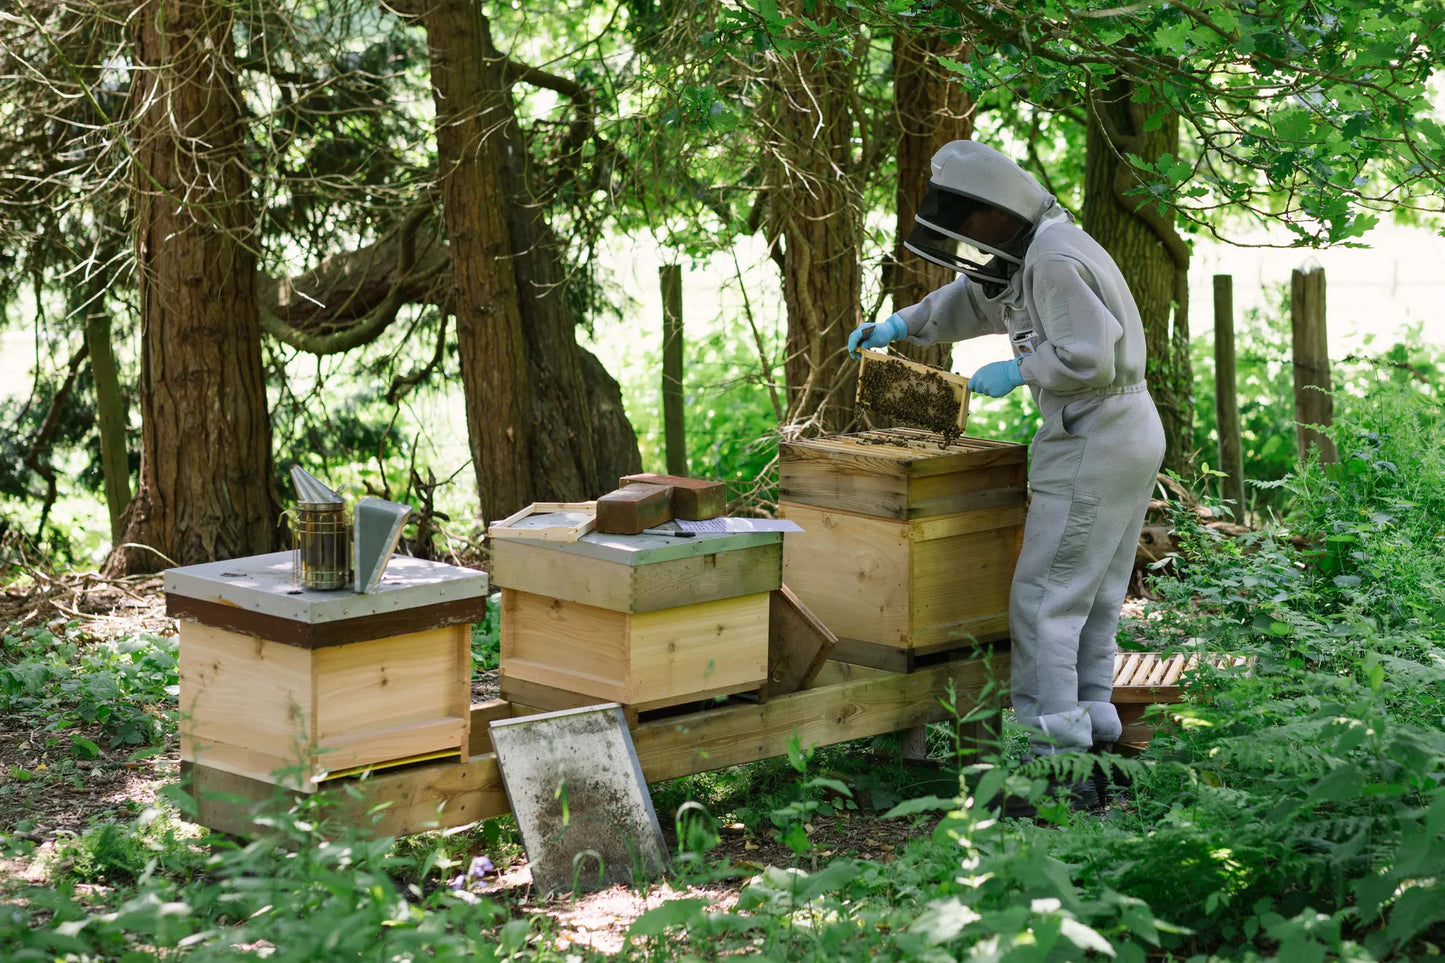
[423,0,642,521]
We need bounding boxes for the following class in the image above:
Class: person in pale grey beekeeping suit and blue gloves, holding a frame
[848,140,1165,786]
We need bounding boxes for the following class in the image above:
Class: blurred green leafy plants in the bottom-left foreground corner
[0,798,514,963]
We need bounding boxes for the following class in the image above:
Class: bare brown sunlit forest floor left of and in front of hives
[0,573,976,953]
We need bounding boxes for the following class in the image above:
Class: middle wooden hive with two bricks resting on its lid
[491,532,782,717]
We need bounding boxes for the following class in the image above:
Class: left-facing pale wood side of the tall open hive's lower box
[779,502,909,649]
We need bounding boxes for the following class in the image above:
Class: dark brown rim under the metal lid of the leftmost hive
[166,593,487,649]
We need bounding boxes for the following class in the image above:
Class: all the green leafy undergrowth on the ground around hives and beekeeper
[0,378,1445,962]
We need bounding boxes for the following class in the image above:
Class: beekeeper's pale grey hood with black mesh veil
[903,140,1062,288]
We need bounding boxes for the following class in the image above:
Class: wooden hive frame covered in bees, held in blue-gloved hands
[857,350,968,445]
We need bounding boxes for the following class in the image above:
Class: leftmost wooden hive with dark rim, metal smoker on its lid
[165,552,487,792]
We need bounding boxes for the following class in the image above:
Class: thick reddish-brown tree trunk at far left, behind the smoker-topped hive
[107,0,280,574]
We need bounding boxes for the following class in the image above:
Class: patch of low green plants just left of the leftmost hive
[0,626,179,758]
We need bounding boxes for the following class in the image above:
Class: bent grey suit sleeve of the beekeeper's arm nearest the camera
[1019,257,1124,393]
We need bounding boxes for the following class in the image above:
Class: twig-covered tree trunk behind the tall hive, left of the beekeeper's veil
[763,0,863,432]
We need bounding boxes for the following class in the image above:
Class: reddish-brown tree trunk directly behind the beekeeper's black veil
[883,30,974,369]
